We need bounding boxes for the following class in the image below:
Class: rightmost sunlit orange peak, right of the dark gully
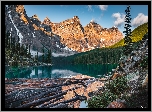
[84,22,123,49]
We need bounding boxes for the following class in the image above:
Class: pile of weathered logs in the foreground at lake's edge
[5,78,104,108]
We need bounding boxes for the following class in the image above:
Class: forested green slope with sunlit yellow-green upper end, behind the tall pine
[53,23,148,64]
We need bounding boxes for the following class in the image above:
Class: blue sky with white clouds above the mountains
[24,5,148,35]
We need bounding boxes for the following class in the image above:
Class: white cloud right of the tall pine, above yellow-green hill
[132,13,148,27]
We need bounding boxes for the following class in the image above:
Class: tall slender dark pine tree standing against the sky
[123,6,132,55]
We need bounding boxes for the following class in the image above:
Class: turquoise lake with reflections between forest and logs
[5,64,117,78]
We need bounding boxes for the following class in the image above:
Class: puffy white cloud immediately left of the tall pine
[112,12,125,27]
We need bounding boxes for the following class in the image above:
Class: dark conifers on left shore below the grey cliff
[5,26,51,66]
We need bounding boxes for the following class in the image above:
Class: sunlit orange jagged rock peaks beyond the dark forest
[43,16,123,52]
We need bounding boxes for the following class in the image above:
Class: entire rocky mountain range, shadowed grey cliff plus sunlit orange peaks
[5,5,123,55]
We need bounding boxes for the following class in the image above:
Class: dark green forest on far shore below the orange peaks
[53,47,123,65]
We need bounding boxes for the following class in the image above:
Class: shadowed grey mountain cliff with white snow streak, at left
[5,5,77,56]
